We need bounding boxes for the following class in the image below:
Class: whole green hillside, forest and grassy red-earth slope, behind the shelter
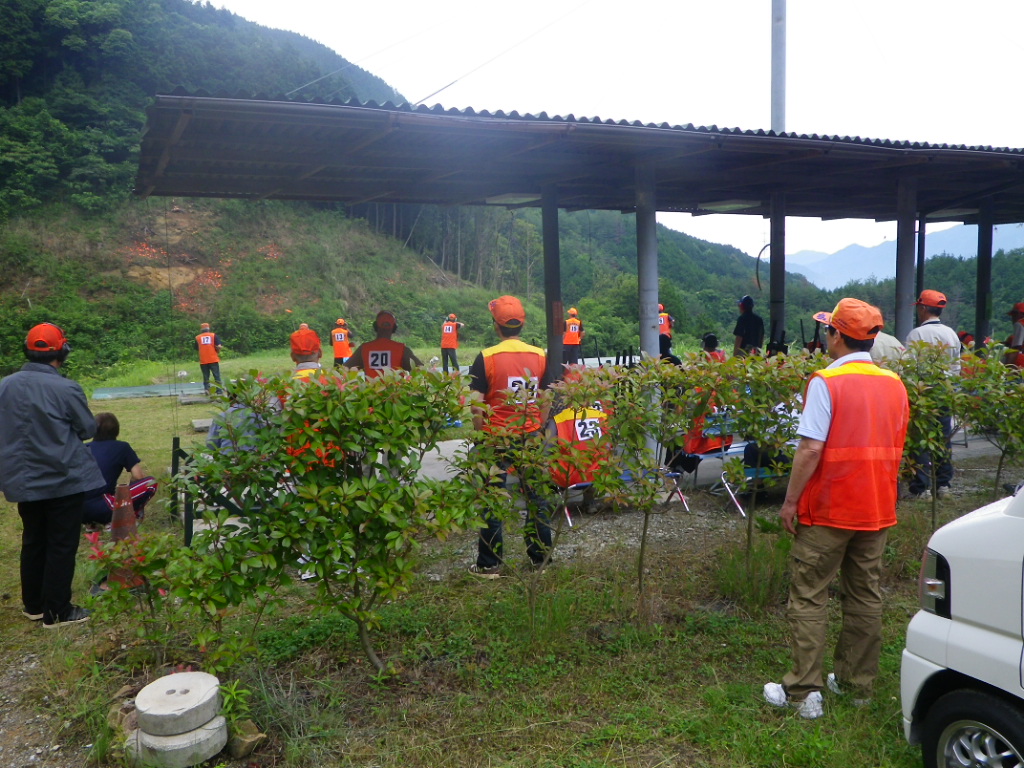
[0,0,828,373]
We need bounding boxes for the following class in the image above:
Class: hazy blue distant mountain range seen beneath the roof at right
[785,224,1024,290]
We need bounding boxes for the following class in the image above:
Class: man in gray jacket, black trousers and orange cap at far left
[0,323,103,628]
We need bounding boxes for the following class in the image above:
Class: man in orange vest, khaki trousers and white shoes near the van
[764,298,909,719]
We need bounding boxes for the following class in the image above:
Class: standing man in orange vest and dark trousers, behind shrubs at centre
[469,296,551,579]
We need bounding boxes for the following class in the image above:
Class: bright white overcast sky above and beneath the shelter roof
[213,0,1024,255]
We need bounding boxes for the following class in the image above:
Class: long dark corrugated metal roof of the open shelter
[137,89,1024,223]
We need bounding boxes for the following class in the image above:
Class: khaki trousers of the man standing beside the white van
[782,525,887,701]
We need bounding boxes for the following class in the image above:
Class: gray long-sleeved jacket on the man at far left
[0,362,103,502]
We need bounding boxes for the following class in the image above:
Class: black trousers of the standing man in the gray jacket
[17,494,85,621]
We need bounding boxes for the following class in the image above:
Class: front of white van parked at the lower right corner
[900,492,1024,768]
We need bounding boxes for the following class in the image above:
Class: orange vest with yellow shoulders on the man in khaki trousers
[797,360,910,530]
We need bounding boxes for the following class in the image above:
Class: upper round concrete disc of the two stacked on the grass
[135,672,223,746]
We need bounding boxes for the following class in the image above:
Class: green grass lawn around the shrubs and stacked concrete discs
[0,357,1007,768]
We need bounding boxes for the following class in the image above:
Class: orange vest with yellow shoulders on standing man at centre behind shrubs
[480,339,548,434]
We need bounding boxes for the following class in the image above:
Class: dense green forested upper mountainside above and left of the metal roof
[0,0,397,220]
